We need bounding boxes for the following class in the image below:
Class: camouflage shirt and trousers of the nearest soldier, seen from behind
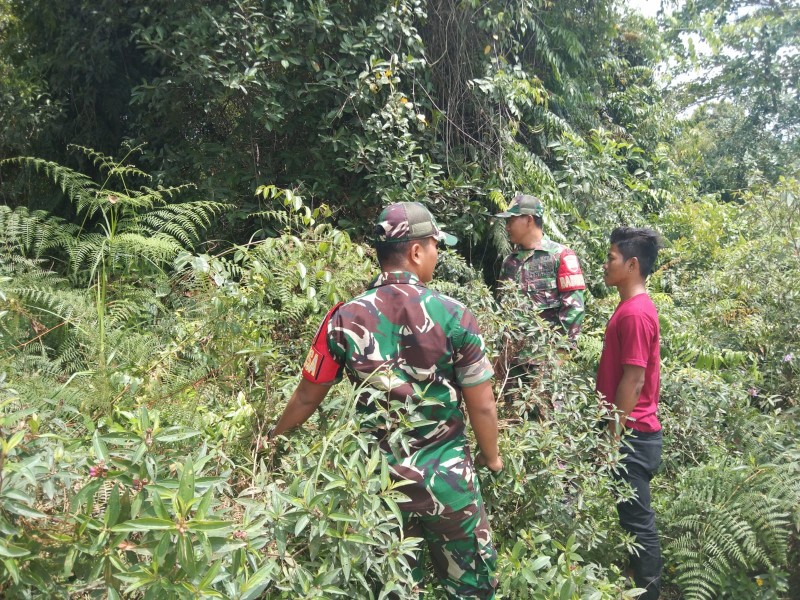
[303,200,497,598]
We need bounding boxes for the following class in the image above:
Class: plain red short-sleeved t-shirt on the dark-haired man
[597,294,661,431]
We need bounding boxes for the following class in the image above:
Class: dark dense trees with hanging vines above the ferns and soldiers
[0,0,680,260]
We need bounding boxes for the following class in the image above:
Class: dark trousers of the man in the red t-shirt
[617,431,662,600]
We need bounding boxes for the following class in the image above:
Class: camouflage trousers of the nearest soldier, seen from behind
[403,492,497,600]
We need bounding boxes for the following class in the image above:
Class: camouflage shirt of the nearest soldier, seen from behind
[327,272,494,515]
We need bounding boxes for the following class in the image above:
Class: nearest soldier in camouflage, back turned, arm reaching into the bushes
[270,202,503,598]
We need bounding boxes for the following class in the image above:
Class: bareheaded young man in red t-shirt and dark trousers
[597,227,662,600]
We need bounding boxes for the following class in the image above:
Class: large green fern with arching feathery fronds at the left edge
[0,148,231,411]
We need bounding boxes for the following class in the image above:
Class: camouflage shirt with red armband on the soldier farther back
[500,238,586,341]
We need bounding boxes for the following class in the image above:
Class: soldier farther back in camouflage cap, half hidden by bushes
[495,194,586,343]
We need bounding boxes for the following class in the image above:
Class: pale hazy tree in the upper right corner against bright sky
[665,0,800,193]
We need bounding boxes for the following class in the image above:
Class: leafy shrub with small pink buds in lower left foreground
[0,386,415,598]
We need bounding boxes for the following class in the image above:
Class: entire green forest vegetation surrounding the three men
[0,0,800,599]
